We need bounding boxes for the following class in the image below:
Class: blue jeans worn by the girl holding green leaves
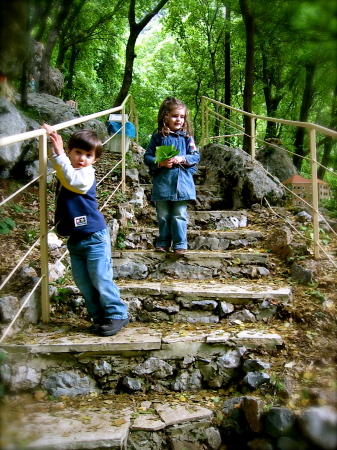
[156,200,187,250]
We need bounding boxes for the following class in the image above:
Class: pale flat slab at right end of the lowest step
[155,403,213,426]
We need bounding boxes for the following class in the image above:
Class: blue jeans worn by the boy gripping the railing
[67,228,128,320]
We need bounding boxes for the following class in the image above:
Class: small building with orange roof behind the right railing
[283,175,330,206]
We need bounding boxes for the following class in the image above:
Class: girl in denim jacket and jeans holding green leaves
[144,97,200,254]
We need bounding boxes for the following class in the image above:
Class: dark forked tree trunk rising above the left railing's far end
[113,0,169,107]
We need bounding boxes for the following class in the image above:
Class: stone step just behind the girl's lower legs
[124,228,264,251]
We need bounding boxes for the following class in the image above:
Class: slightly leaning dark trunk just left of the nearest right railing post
[293,63,316,172]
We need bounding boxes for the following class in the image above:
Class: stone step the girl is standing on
[113,249,270,280]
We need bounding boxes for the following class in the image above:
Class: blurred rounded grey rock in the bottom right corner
[298,406,337,450]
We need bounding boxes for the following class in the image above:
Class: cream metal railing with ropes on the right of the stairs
[201,97,337,259]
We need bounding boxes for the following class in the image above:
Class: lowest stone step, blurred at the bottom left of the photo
[1,392,221,450]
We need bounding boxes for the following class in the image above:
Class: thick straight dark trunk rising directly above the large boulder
[239,0,255,153]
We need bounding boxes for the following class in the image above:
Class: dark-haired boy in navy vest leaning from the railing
[42,124,129,336]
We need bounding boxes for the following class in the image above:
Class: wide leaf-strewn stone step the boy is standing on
[2,322,283,404]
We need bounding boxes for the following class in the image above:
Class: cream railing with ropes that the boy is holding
[0,95,138,341]
